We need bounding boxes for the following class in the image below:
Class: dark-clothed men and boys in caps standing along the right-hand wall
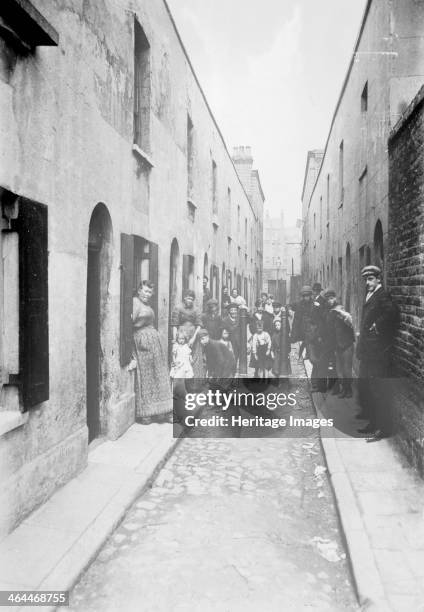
[291,265,399,441]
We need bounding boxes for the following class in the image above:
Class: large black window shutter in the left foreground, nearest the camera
[17,198,49,410]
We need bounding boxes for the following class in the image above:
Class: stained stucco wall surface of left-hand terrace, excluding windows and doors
[0,0,262,532]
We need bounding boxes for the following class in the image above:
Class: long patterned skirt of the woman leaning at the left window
[134,327,172,417]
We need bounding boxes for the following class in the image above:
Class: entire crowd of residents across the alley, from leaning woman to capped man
[129,266,398,439]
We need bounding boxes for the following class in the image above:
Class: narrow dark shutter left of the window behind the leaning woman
[120,234,134,366]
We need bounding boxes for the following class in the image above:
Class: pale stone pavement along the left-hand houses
[0,424,177,610]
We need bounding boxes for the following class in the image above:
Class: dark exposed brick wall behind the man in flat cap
[387,87,424,474]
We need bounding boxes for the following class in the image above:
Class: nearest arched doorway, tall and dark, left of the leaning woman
[86,203,112,442]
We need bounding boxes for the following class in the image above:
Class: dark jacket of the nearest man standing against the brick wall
[356,288,399,360]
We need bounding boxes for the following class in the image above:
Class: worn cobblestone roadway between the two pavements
[65,382,357,612]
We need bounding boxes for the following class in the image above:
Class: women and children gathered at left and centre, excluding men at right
[128,277,294,423]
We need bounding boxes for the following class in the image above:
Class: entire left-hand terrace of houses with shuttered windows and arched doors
[0,0,264,536]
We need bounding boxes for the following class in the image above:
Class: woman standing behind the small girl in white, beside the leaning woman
[171,289,205,378]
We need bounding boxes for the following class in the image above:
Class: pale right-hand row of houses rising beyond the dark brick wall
[302,0,424,327]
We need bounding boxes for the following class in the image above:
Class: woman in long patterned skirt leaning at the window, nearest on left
[132,281,172,423]
